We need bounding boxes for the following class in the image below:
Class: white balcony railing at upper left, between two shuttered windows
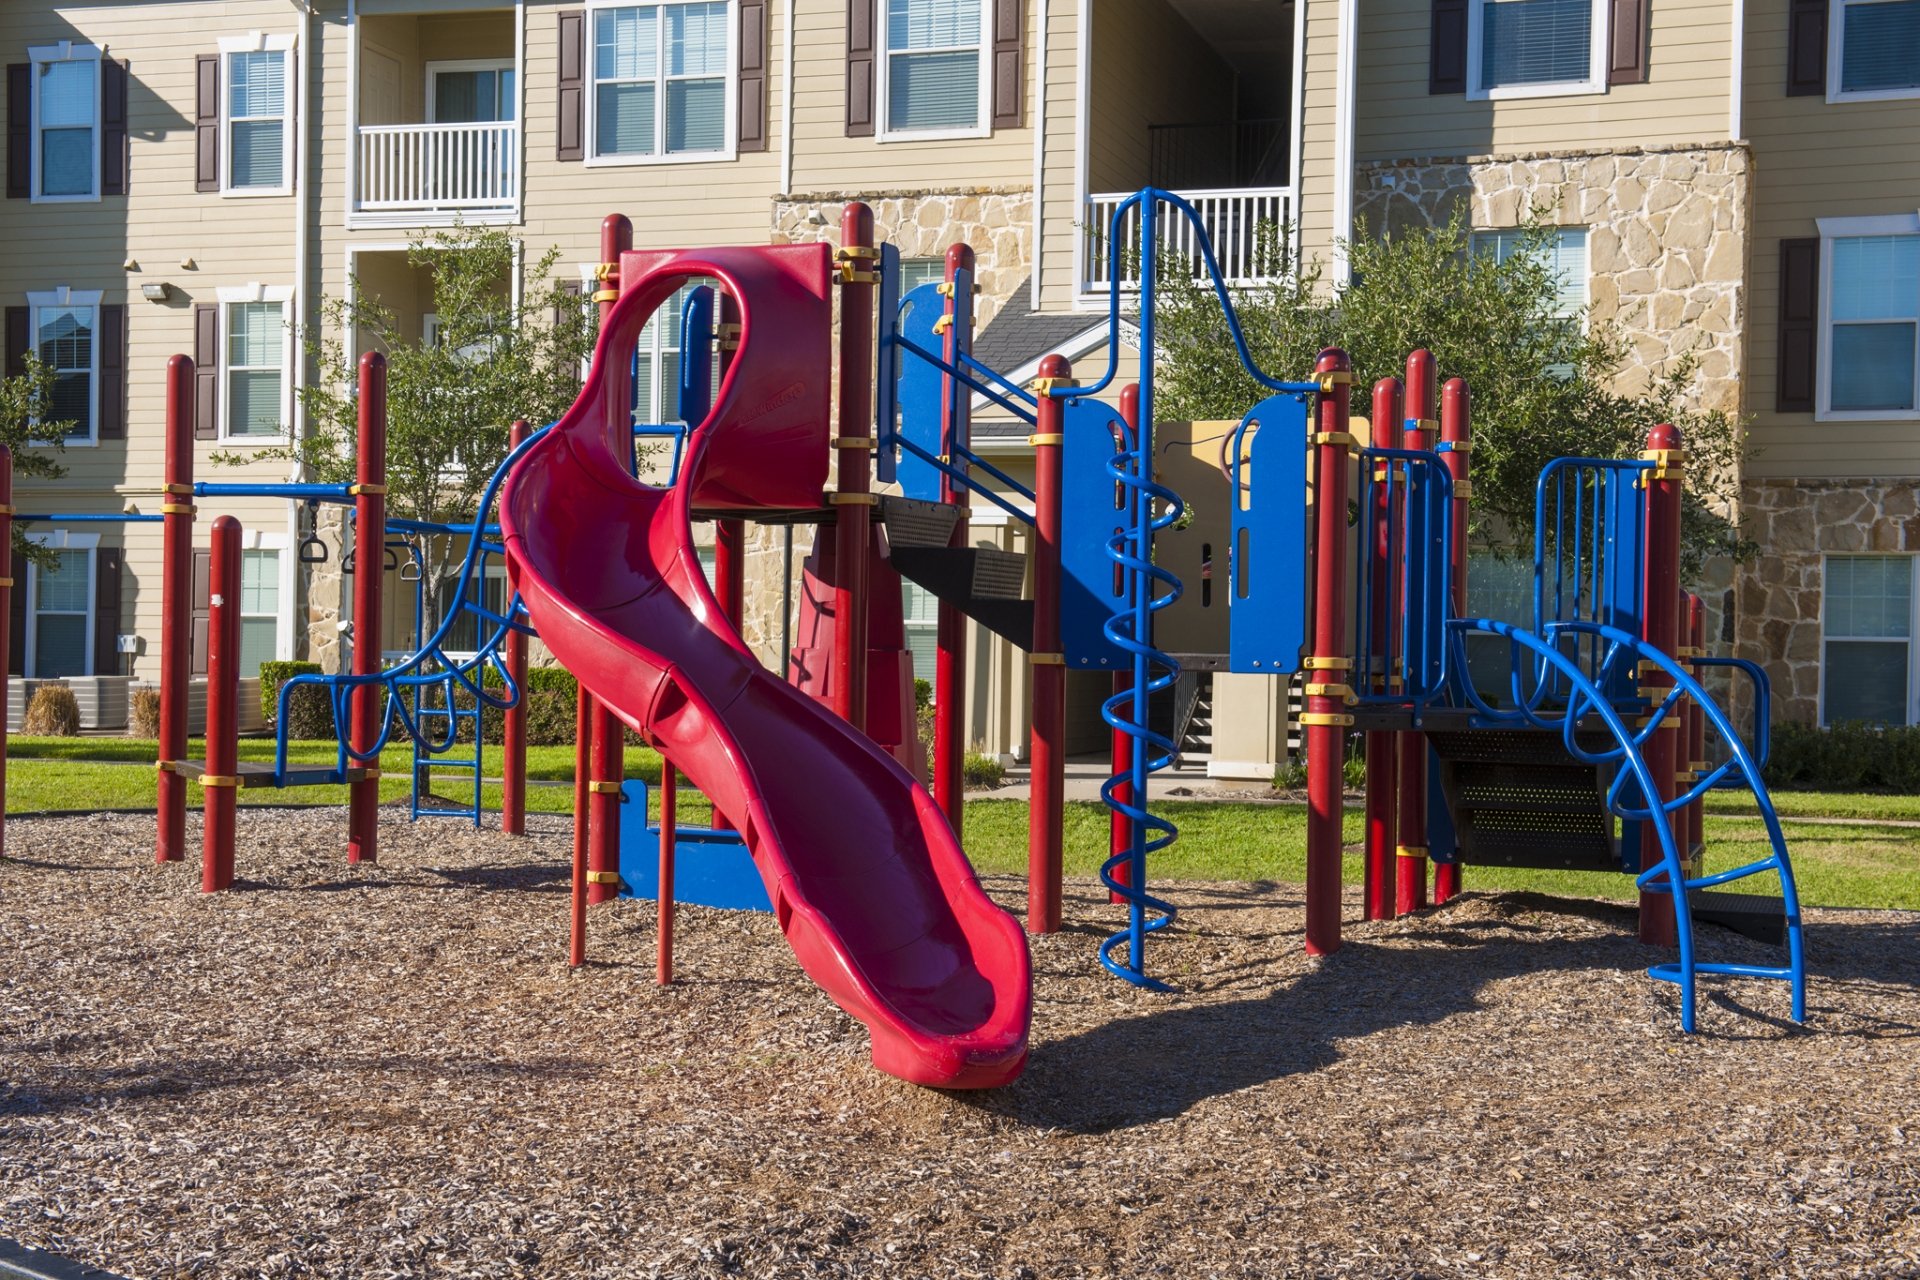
[357,121,520,211]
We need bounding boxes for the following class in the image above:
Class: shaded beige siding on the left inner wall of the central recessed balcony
[1087,0,1235,192]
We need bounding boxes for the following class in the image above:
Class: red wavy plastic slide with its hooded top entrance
[501,244,1033,1088]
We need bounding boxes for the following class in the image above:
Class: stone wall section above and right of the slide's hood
[774,186,1033,328]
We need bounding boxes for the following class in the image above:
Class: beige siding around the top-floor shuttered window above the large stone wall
[1351,0,1732,161]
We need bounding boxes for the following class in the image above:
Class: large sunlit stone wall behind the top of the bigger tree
[1356,146,1753,413]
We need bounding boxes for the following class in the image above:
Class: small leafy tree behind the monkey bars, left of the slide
[239,226,599,635]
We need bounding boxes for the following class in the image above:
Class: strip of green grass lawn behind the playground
[6,737,1920,910]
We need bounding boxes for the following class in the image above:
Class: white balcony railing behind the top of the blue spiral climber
[1081,186,1294,294]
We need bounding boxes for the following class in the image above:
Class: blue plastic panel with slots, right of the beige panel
[1221,391,1308,676]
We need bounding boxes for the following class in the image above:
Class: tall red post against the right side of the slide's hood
[831,200,877,733]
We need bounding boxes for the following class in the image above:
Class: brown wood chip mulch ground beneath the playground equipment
[0,810,1920,1280]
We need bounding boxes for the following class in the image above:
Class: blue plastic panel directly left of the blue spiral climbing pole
[1060,399,1133,672]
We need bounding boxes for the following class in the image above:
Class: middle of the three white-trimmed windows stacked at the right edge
[1820,230,1920,410]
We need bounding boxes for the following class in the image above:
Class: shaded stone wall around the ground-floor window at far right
[1736,480,1920,722]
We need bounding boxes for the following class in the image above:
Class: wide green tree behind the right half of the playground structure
[1156,209,1755,578]
